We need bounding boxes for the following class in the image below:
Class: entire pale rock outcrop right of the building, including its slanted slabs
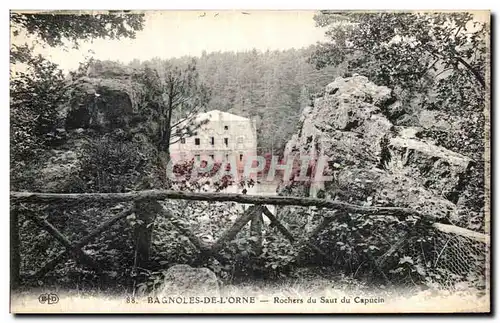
[280,75,471,224]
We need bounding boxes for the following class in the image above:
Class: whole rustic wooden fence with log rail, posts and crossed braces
[10,190,489,286]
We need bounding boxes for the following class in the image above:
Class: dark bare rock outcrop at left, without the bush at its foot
[29,68,161,192]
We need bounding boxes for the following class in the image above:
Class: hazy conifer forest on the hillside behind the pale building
[82,46,342,155]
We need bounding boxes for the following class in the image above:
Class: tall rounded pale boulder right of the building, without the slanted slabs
[285,76,393,176]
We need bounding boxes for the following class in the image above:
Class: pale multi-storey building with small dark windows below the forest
[170,110,257,171]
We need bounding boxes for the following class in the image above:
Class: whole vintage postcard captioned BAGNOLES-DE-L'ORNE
[10,10,491,314]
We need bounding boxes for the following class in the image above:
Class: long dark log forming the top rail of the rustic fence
[10,190,422,218]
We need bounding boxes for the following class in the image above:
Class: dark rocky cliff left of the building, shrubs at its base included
[30,68,158,192]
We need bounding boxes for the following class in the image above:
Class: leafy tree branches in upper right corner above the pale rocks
[311,12,487,106]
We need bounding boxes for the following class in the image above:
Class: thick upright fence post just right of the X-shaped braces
[134,200,157,268]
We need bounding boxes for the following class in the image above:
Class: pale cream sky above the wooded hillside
[13,10,324,70]
